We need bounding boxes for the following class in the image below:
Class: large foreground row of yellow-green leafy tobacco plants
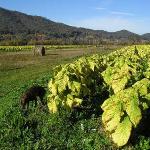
[48,45,150,147]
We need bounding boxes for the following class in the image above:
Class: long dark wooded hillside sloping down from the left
[0,8,150,45]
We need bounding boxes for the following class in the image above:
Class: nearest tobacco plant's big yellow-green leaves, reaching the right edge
[101,78,150,146]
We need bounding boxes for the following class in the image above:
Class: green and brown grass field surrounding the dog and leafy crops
[0,47,149,150]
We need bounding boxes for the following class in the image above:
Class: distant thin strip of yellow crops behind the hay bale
[0,45,90,52]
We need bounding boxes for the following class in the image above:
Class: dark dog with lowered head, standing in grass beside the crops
[21,85,46,109]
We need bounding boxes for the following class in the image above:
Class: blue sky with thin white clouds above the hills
[0,0,150,34]
